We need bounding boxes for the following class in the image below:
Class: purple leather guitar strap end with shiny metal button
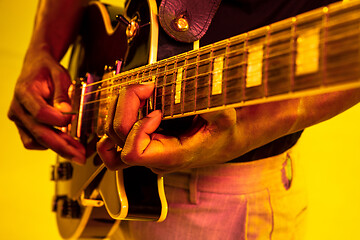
[159,0,221,43]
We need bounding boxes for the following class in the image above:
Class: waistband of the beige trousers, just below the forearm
[164,148,293,197]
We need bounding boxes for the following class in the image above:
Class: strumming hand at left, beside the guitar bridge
[8,49,85,164]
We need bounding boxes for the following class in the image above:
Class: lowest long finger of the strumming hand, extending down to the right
[8,100,85,164]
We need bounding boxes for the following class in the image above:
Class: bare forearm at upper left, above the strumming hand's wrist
[29,0,87,61]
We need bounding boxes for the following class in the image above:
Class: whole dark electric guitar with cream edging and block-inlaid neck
[53,0,360,239]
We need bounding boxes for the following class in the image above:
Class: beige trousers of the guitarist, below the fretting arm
[112,145,307,240]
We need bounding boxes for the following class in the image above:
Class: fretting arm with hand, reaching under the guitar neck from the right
[98,85,360,173]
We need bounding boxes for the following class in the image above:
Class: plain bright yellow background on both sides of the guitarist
[0,0,360,240]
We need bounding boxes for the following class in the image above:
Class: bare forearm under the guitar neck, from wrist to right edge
[236,89,360,158]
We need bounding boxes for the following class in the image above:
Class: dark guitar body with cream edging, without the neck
[53,0,167,239]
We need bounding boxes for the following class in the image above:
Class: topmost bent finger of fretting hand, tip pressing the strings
[114,83,154,142]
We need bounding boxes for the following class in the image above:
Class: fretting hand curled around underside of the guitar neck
[98,84,246,173]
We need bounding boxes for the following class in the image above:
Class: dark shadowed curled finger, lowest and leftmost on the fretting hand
[96,135,127,170]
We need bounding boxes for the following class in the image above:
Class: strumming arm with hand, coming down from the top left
[8,0,86,163]
